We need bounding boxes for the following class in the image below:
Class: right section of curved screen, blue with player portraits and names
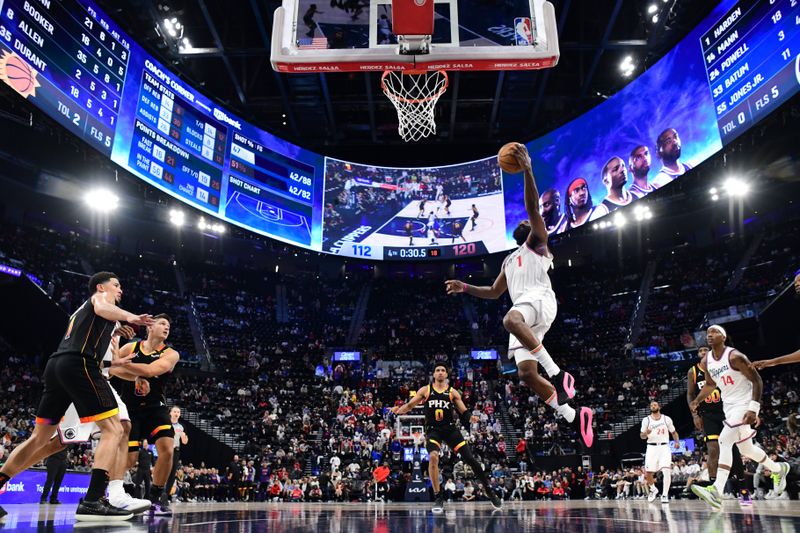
[503,0,800,241]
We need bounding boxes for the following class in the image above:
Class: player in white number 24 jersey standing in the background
[639,401,681,503]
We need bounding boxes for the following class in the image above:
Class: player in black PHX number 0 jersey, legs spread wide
[392,363,502,513]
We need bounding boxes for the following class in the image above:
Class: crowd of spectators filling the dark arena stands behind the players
[0,215,800,501]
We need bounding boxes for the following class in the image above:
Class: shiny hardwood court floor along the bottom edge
[0,500,800,533]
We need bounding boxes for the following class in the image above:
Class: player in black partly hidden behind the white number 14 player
[686,346,750,505]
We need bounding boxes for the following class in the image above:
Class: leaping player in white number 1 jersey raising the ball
[445,143,594,447]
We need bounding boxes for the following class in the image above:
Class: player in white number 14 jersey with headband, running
[690,325,789,509]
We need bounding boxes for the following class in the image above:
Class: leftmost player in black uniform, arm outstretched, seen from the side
[0,272,153,521]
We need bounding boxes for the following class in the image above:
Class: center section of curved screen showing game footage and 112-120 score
[322,157,506,259]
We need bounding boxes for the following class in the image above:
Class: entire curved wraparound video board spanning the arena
[0,0,800,260]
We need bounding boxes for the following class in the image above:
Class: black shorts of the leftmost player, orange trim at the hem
[36,354,119,426]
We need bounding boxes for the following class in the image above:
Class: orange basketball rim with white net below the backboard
[381,70,448,142]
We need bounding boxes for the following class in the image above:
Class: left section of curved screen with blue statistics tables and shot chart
[0,0,323,249]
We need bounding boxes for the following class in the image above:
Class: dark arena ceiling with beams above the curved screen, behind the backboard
[100,0,715,163]
